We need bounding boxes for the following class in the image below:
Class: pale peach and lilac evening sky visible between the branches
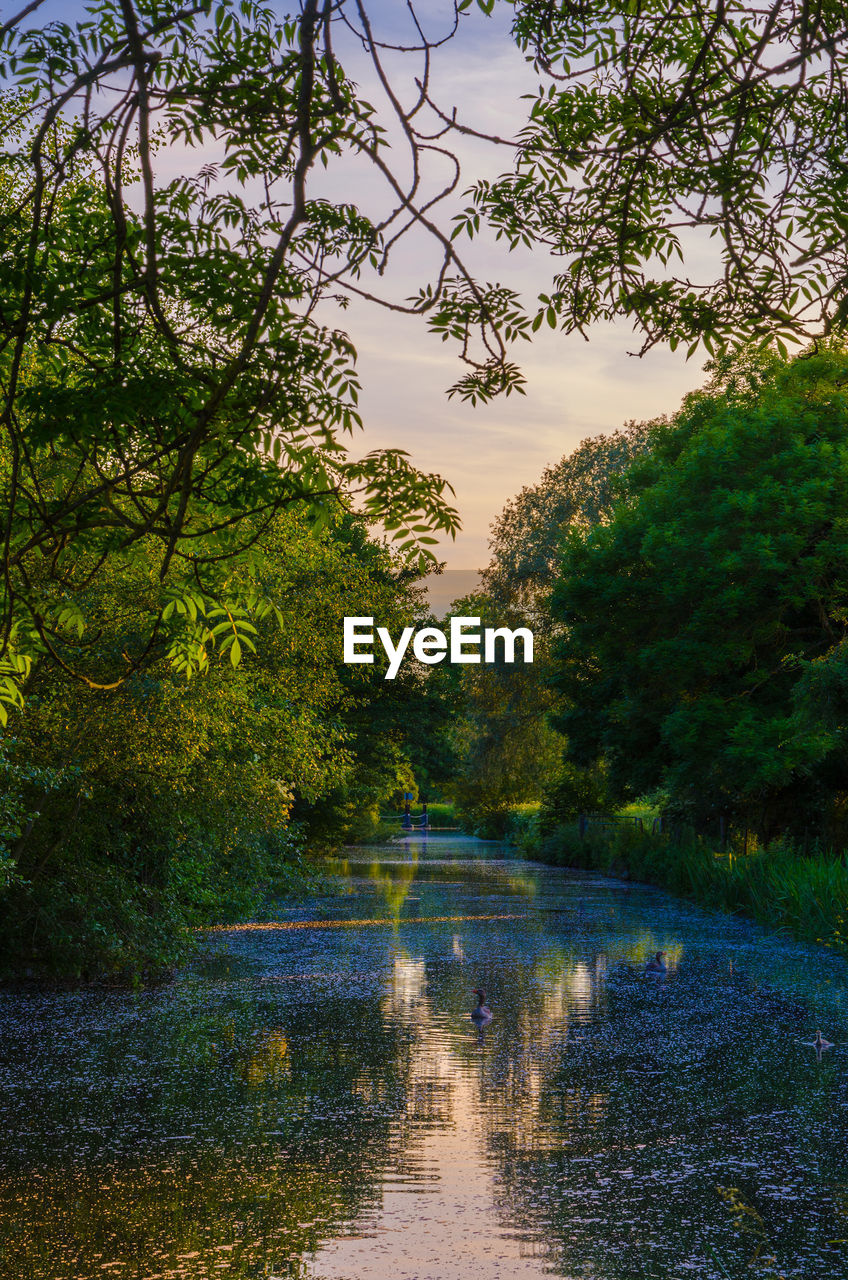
[18,0,705,571]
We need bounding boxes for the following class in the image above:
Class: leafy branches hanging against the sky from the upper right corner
[457,0,848,353]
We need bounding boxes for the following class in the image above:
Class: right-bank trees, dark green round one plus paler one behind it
[450,343,848,849]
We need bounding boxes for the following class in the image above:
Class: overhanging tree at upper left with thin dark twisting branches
[0,0,545,714]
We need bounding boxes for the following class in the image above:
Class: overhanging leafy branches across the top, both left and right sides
[8,0,848,714]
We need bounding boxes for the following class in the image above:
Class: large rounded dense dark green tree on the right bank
[553,347,848,840]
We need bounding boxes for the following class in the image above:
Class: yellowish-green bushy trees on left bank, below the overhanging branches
[0,511,438,977]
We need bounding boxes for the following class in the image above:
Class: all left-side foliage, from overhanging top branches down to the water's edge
[0,0,499,977]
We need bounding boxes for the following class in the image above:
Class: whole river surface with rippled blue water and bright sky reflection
[0,837,848,1280]
